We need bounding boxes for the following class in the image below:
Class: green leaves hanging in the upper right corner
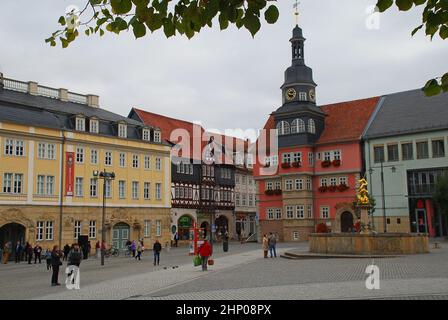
[377,0,448,96]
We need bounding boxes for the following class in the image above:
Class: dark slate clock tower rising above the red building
[272,25,325,147]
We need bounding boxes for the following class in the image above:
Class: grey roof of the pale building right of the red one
[364,89,448,139]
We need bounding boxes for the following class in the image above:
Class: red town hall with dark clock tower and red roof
[254,26,379,241]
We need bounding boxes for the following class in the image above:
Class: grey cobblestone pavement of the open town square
[0,242,448,300]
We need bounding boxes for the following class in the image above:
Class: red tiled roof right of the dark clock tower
[317,97,380,144]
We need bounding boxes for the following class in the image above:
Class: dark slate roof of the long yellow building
[0,89,161,140]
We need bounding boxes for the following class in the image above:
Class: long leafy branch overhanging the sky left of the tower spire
[46,0,279,48]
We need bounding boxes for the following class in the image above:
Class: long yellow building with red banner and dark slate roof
[0,77,171,252]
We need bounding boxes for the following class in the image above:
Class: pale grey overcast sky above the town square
[0,0,448,141]
